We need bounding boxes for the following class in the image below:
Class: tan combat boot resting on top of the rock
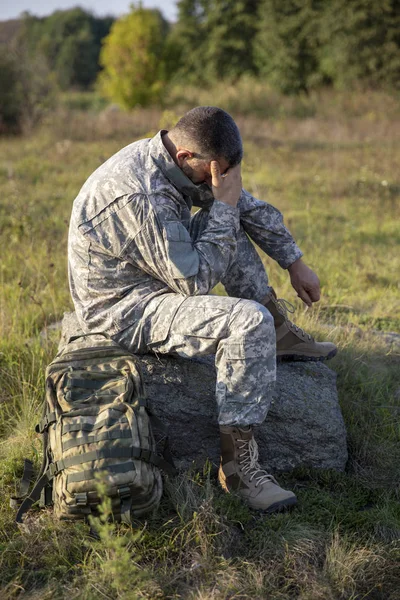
[263,288,337,361]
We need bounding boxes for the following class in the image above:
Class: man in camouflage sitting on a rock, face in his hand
[69,106,336,512]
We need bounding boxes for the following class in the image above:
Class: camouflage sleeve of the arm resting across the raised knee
[238,190,303,269]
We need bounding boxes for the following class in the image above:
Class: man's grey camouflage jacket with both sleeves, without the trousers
[68,131,302,335]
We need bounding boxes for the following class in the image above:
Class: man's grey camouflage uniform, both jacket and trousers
[68,131,302,425]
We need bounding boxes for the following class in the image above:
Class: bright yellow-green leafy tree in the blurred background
[99,6,168,108]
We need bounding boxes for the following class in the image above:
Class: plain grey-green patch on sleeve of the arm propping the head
[163,221,199,279]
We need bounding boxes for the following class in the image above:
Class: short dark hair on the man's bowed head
[171,106,243,167]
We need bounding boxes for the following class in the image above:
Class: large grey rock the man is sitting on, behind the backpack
[60,313,347,471]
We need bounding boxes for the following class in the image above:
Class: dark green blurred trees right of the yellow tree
[171,0,400,93]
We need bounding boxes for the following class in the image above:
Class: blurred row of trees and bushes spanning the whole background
[0,0,400,131]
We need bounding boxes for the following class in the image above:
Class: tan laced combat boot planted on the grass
[218,426,297,512]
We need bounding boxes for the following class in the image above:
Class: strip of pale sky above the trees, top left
[0,0,176,21]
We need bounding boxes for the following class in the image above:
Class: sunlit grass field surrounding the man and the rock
[0,90,400,600]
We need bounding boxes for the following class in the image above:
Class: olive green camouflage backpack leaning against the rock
[12,334,175,523]
